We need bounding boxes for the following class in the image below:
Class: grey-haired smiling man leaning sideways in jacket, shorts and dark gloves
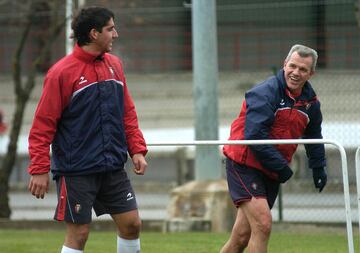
[221,45,327,253]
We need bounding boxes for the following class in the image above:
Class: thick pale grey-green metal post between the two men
[192,0,221,180]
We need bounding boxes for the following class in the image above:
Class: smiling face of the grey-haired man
[284,52,314,93]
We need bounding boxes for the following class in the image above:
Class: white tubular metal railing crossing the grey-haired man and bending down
[147,139,354,253]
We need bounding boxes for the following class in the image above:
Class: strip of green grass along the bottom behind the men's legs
[0,229,358,253]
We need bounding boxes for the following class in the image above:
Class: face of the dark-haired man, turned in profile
[90,18,118,53]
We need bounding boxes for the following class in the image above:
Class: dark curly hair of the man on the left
[71,6,115,46]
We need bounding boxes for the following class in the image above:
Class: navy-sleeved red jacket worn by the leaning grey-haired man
[223,70,326,179]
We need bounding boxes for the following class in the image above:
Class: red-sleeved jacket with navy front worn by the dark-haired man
[28,45,147,176]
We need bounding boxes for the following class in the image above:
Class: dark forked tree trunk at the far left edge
[0,0,66,219]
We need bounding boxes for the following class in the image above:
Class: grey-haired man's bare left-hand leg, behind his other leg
[220,208,251,253]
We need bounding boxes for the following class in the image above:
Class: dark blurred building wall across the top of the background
[0,0,360,73]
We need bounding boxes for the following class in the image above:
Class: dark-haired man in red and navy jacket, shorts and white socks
[28,7,147,253]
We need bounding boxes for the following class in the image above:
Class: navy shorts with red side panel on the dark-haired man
[54,170,137,224]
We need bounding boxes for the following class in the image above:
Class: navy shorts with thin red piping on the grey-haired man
[226,158,279,209]
